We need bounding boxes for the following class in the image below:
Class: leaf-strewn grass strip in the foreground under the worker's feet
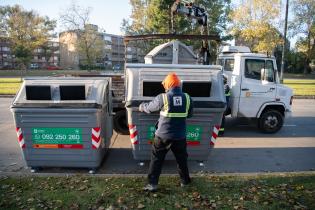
[0,174,315,210]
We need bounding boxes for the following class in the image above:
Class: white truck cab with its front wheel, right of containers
[218,46,293,133]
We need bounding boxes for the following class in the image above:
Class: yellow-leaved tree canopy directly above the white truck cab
[230,0,282,53]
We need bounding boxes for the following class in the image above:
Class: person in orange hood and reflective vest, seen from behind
[139,73,193,192]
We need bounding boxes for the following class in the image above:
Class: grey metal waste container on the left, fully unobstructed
[11,77,112,173]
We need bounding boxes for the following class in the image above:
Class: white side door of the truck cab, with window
[238,58,276,117]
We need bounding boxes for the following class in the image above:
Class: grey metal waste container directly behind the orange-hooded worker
[125,64,226,162]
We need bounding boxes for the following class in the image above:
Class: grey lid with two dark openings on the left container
[11,77,110,108]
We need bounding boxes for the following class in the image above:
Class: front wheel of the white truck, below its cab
[258,110,283,133]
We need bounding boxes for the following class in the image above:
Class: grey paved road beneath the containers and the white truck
[0,98,315,174]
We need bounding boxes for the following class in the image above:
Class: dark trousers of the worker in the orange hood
[148,136,190,185]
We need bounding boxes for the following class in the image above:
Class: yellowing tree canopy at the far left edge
[0,5,56,68]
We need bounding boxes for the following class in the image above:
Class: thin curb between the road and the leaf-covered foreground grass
[0,171,315,180]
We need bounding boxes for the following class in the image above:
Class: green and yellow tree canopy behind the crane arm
[121,0,230,54]
